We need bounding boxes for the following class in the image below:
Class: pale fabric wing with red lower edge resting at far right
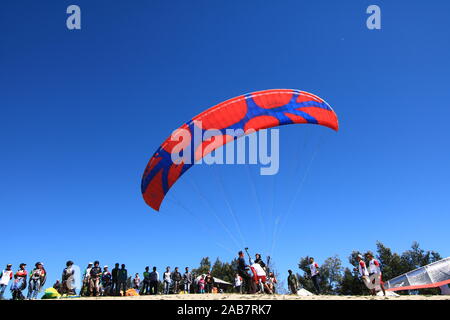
[384,257,450,291]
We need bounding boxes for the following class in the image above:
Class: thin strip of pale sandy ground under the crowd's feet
[67,294,450,301]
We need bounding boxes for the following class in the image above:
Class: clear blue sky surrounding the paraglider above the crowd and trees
[0,0,450,294]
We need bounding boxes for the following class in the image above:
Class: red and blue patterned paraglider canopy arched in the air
[141,89,338,211]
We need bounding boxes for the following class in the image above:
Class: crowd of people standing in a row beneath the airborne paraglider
[0,251,385,300]
